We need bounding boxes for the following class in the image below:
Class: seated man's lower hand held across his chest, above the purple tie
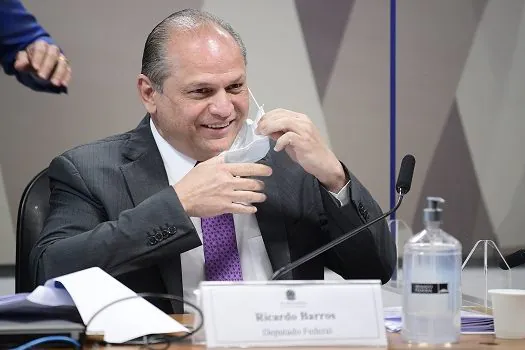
[173,156,272,217]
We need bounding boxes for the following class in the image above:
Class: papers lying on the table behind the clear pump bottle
[384,306,494,334]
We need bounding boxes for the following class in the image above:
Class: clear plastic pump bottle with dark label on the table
[401,197,461,344]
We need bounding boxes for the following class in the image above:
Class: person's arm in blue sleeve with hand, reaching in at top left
[0,0,71,93]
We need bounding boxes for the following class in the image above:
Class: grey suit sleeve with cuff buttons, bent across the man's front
[31,156,201,283]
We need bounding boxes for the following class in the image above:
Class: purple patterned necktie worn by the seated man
[201,214,242,281]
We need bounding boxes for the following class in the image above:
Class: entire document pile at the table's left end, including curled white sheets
[0,267,189,343]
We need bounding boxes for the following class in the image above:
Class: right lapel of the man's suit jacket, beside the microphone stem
[255,153,292,279]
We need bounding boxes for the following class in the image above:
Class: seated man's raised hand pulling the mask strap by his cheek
[256,109,348,193]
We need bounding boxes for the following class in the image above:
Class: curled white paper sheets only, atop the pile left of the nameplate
[45,267,188,343]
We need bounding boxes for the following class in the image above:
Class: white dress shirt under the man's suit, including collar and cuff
[150,119,350,302]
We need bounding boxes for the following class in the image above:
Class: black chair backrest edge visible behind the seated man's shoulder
[15,168,50,293]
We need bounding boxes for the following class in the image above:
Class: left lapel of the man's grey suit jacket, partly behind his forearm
[120,116,183,302]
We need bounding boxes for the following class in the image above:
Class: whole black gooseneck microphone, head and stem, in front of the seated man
[271,154,416,280]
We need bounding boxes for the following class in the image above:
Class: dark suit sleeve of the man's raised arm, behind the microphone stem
[320,167,397,283]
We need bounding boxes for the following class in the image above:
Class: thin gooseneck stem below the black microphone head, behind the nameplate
[270,188,405,281]
